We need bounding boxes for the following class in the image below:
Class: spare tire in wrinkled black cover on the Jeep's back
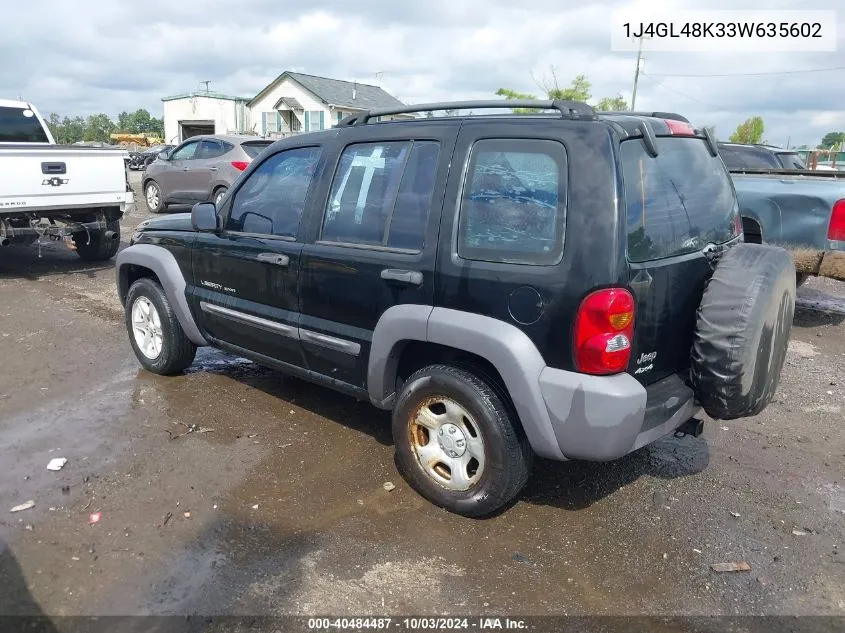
[690,244,795,420]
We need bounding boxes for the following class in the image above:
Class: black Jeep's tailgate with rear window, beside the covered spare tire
[619,132,739,384]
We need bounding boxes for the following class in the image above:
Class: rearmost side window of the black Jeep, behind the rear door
[458,139,567,266]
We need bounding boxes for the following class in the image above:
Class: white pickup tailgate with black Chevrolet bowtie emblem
[0,144,127,215]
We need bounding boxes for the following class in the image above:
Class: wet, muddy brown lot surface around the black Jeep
[0,172,845,615]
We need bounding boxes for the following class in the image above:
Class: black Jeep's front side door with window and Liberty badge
[191,143,321,367]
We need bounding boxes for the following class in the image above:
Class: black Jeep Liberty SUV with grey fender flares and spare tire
[117,101,795,516]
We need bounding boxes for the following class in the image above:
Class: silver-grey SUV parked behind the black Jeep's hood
[143,135,272,213]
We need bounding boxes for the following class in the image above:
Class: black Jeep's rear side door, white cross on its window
[300,122,458,389]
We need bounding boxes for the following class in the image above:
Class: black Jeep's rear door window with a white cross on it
[321,141,440,251]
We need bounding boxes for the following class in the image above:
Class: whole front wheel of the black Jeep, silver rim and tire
[124,277,197,376]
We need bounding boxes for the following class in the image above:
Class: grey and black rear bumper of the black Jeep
[539,367,699,461]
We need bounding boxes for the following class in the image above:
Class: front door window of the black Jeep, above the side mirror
[226,147,320,237]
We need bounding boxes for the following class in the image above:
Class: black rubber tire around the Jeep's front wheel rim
[124,277,197,376]
